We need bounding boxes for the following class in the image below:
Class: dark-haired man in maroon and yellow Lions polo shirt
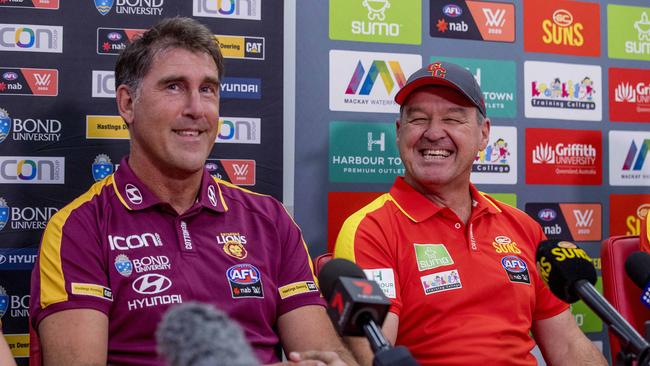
[30,18,354,365]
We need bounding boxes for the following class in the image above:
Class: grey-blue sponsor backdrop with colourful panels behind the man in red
[294,0,650,362]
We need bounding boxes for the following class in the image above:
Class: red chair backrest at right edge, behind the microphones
[600,236,650,360]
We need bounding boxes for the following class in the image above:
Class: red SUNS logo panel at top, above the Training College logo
[524,0,600,56]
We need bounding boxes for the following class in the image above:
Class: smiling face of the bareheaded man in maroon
[117,48,219,175]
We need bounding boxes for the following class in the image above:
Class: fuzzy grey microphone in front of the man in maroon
[156,302,260,366]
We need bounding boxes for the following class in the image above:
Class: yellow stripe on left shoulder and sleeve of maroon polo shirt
[39,174,113,309]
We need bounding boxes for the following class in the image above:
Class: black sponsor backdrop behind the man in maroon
[0,0,282,365]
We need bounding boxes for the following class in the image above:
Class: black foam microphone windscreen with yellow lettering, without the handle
[536,240,598,303]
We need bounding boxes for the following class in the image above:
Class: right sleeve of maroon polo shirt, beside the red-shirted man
[277,202,325,315]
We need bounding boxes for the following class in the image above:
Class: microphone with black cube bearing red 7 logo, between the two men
[318,258,418,366]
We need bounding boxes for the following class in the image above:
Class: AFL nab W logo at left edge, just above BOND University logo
[0,67,59,97]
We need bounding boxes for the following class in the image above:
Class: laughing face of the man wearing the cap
[397,87,490,193]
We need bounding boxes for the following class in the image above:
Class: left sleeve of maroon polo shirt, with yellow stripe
[30,199,113,329]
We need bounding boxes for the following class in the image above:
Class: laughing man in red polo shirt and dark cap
[335,62,607,366]
